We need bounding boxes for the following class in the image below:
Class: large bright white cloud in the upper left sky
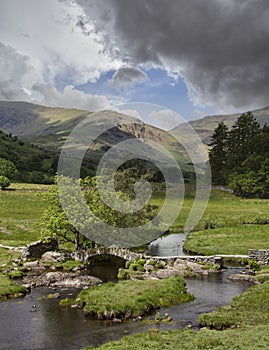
[0,0,119,110]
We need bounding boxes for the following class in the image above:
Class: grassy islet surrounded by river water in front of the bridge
[61,276,193,319]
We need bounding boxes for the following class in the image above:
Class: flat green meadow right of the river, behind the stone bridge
[152,190,269,255]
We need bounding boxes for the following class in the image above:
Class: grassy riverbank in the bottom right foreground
[87,282,269,350]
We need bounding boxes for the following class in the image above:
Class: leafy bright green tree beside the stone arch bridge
[41,177,157,250]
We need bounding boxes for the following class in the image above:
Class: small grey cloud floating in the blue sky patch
[109,67,148,90]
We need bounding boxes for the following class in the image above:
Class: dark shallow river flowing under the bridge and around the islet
[0,235,249,350]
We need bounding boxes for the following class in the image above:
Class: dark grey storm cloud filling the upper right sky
[77,0,269,108]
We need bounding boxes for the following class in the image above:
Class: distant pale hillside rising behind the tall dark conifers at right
[185,106,269,144]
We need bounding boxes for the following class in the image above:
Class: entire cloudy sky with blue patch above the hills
[0,0,269,120]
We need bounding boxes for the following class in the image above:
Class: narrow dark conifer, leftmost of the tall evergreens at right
[209,122,228,185]
